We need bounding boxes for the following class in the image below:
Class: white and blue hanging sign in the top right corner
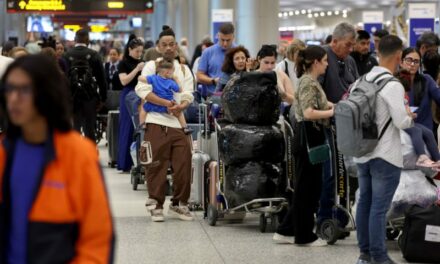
[408,3,436,47]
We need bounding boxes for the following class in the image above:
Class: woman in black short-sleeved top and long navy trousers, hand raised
[117,35,144,172]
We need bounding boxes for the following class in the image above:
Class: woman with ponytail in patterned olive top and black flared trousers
[273,46,334,246]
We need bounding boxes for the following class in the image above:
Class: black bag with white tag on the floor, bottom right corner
[399,205,440,263]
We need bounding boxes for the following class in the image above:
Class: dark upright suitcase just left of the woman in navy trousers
[107,110,119,168]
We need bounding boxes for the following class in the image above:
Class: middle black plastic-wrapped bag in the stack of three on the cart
[219,124,285,165]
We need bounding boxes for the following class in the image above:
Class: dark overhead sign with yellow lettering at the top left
[6,0,154,14]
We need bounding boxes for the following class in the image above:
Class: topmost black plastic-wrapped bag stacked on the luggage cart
[222,72,281,126]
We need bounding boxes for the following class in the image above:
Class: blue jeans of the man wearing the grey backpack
[356,159,402,262]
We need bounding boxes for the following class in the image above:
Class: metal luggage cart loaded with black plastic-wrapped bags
[199,104,294,232]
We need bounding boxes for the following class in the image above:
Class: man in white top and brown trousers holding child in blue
[135,26,194,222]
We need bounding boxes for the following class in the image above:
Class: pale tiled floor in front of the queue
[100,146,412,264]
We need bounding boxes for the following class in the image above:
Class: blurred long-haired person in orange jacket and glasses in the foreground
[0,55,114,264]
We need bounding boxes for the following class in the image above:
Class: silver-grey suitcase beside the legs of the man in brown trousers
[188,151,210,209]
